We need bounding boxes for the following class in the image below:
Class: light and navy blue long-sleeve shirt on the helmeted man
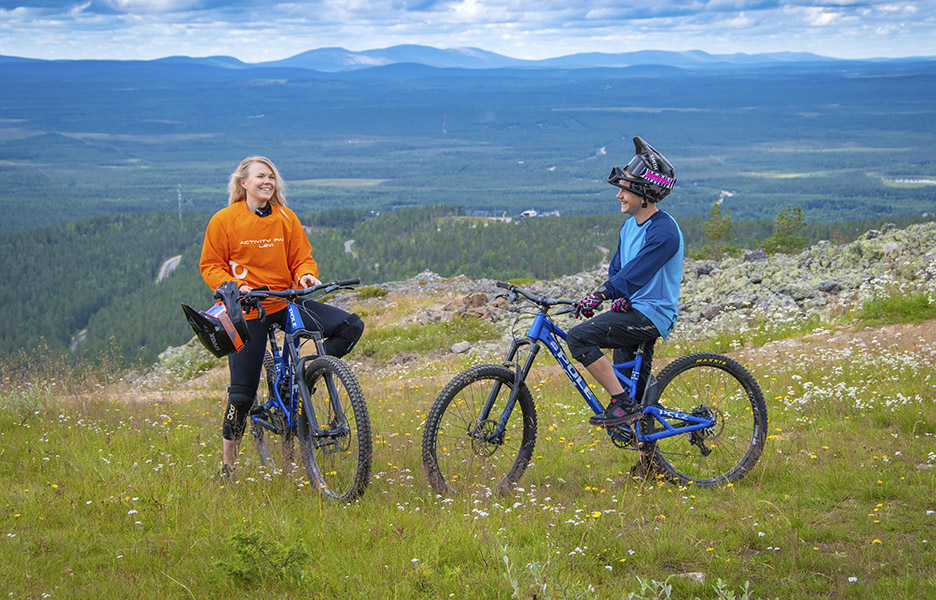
[605,211,683,339]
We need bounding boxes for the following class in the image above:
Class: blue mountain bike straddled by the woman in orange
[240,279,373,501]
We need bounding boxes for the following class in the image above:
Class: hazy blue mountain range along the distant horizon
[0,45,928,72]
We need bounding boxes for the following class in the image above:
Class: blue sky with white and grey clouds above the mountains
[0,0,936,62]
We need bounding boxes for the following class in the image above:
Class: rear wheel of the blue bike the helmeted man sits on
[641,352,767,488]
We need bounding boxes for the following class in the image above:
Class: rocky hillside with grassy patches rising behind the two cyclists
[134,223,936,394]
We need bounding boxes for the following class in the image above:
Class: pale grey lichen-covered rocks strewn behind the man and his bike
[372,223,936,344]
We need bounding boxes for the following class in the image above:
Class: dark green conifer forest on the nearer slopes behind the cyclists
[0,205,922,368]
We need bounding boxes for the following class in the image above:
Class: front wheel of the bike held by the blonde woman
[296,356,373,502]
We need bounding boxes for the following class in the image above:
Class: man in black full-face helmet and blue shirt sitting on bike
[566,137,683,427]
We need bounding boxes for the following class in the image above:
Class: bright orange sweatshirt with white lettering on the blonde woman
[199,202,318,319]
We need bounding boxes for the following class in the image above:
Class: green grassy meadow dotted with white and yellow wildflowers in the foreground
[0,310,936,598]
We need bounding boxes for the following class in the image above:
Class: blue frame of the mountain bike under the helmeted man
[479,310,715,442]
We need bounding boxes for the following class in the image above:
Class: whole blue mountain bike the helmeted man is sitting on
[422,282,767,496]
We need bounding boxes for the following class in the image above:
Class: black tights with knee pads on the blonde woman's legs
[221,300,364,440]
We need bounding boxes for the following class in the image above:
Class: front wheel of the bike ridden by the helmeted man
[422,365,536,496]
